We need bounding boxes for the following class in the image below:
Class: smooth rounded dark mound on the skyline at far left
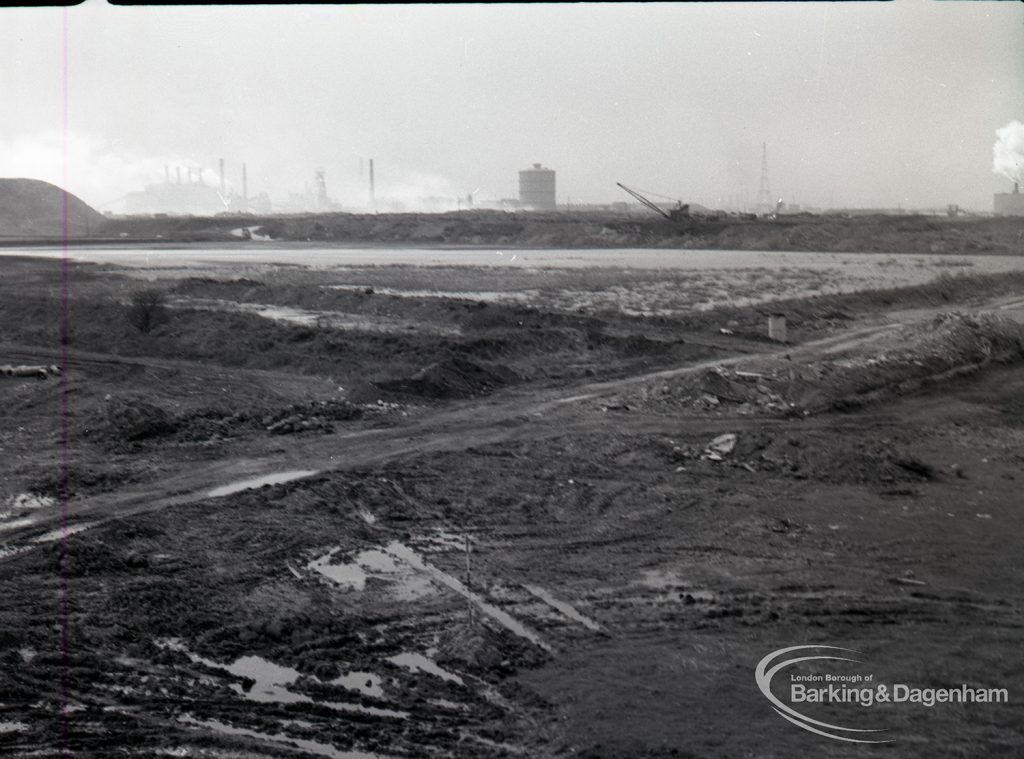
[0,179,105,238]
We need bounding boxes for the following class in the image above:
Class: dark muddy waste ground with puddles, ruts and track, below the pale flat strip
[0,258,1024,758]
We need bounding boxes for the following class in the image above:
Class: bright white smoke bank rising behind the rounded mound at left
[0,129,230,211]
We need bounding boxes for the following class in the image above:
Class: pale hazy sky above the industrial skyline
[0,0,1024,210]
